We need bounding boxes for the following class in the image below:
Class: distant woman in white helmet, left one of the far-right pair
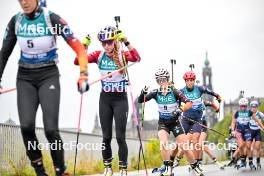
[231,98,263,169]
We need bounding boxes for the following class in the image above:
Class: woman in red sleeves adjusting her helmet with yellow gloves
[75,26,140,176]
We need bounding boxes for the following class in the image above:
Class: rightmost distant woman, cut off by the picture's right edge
[249,100,264,169]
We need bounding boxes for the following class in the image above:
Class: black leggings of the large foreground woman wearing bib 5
[17,76,64,168]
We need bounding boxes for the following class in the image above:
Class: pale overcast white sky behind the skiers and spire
[0,0,264,132]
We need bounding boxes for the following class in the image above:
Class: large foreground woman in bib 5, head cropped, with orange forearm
[0,0,89,176]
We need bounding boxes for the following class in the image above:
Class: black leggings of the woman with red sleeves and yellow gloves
[99,92,128,163]
